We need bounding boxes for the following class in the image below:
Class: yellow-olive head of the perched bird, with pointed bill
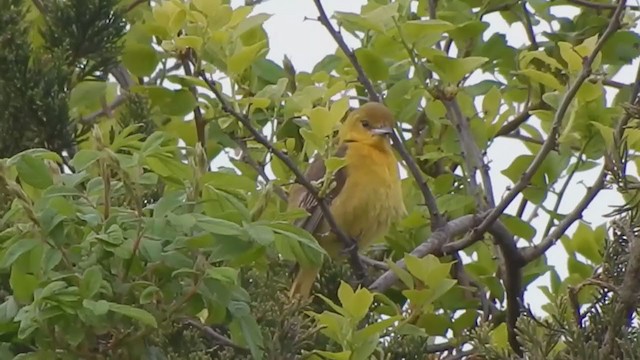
[339,102,394,148]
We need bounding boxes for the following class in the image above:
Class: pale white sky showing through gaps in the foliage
[224,0,635,312]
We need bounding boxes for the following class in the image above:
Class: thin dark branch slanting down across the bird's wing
[200,72,365,281]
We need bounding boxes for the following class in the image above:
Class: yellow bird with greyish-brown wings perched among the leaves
[288,102,406,298]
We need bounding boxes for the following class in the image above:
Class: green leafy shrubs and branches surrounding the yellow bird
[0,0,640,360]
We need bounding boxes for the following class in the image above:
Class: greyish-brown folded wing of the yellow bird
[289,144,347,234]
